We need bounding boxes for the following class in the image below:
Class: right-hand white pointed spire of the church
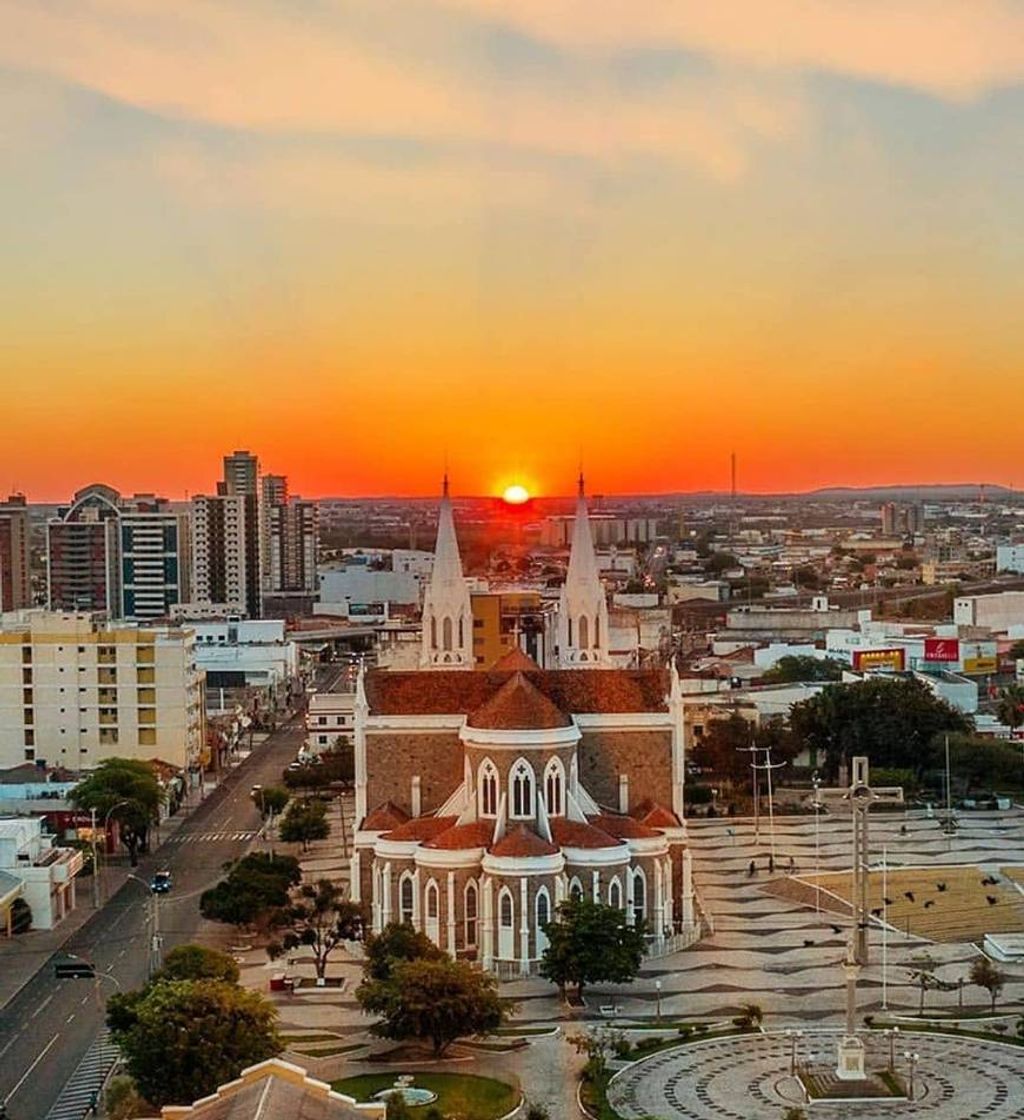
[558,472,609,669]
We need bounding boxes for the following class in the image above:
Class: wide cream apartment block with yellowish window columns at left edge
[0,610,205,771]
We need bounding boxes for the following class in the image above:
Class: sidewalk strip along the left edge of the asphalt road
[0,766,239,1011]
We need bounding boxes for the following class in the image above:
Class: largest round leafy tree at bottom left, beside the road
[108,980,282,1108]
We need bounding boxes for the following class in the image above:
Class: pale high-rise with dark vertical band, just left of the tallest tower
[192,494,250,615]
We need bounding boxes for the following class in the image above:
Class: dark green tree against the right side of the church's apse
[540,898,645,999]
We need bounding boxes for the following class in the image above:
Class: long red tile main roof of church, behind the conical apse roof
[366,669,669,716]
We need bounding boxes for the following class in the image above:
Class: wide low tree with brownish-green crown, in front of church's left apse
[356,954,509,1057]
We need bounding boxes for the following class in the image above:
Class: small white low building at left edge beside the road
[0,816,83,934]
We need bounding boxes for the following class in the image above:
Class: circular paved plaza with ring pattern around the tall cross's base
[608,1033,1024,1120]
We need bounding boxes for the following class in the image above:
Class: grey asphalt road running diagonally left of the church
[0,707,311,1120]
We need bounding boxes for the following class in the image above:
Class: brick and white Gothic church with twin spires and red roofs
[352,478,696,979]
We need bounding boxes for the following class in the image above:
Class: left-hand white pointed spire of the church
[420,470,473,669]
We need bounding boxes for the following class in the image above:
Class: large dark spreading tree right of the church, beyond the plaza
[790,678,972,778]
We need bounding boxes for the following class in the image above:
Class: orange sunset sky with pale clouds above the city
[0,0,1024,501]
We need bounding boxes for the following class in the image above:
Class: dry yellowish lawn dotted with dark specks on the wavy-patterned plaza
[799,867,1024,942]
